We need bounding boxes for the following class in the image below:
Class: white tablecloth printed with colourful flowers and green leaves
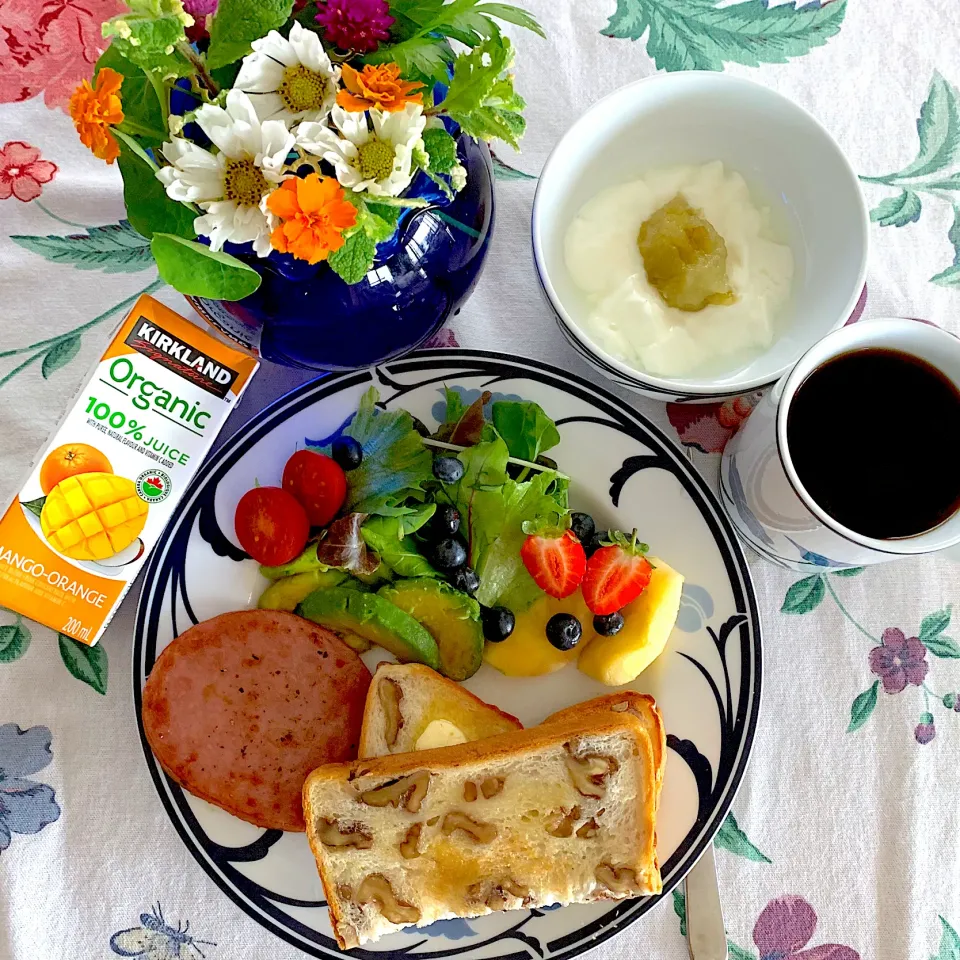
[0,0,960,960]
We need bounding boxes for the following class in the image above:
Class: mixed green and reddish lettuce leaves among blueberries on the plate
[290,387,569,612]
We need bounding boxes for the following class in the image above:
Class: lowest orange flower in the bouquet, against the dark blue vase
[267,173,357,263]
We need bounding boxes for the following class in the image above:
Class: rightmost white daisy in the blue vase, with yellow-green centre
[297,103,427,197]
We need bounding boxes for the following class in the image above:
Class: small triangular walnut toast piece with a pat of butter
[358,663,523,757]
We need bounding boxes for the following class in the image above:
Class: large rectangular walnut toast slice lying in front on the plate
[303,711,662,949]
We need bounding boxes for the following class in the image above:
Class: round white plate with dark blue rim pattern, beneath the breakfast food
[134,350,761,960]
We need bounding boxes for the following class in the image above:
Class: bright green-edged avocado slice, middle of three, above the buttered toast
[297,587,440,670]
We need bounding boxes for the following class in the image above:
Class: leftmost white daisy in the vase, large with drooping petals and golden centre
[157,90,294,257]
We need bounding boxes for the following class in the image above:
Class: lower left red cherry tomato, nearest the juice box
[233,487,310,567]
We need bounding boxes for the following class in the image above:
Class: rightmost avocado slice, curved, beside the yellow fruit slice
[377,577,483,680]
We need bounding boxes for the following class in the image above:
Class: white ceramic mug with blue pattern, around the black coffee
[720,319,960,571]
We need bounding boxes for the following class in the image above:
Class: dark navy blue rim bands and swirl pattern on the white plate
[133,350,761,960]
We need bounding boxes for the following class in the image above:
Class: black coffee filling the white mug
[787,348,960,540]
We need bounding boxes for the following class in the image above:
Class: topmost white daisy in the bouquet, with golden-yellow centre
[233,22,340,125]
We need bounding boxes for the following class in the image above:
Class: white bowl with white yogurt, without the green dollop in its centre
[532,71,868,402]
